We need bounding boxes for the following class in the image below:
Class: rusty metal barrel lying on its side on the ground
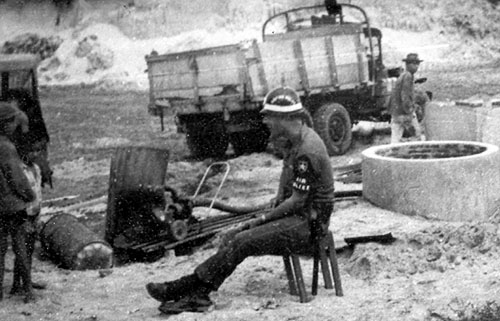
[40,213,113,270]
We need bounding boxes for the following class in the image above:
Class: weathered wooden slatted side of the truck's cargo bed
[146,26,369,113]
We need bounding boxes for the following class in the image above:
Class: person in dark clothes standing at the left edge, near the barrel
[0,103,35,302]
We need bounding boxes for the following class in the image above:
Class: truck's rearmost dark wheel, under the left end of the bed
[186,128,229,157]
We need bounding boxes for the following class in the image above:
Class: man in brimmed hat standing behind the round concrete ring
[390,53,425,144]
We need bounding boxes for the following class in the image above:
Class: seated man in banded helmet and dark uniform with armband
[146,87,334,314]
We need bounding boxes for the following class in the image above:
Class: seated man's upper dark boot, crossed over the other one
[146,274,201,302]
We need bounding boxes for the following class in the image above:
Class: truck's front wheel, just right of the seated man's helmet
[313,103,352,156]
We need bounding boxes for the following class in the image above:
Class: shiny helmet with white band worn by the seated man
[260,87,304,116]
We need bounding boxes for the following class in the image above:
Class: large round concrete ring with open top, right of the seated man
[362,141,500,221]
